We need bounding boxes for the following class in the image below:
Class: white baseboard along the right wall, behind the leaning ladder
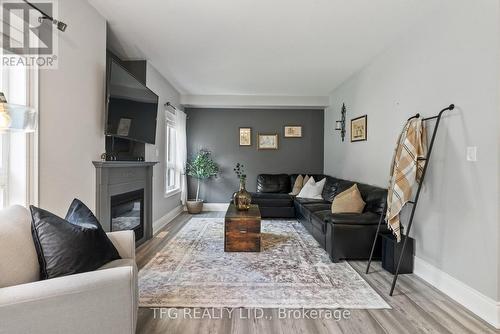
[414,257,500,329]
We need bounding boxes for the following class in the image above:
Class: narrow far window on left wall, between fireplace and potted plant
[165,110,180,195]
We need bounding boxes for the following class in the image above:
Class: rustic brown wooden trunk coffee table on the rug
[224,204,261,252]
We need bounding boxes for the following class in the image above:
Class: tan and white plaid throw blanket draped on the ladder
[385,118,427,242]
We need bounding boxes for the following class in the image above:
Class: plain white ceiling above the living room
[89,0,441,96]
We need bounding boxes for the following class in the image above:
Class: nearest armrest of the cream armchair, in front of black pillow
[0,266,137,334]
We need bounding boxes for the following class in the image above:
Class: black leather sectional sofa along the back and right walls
[252,174,389,262]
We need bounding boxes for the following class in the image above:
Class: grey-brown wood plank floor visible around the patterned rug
[137,212,500,334]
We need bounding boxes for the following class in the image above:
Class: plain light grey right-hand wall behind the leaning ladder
[325,0,500,300]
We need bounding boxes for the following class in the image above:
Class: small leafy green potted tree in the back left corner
[186,150,219,214]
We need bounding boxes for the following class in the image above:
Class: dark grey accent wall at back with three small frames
[186,108,324,203]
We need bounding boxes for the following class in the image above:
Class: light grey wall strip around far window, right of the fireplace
[146,63,181,226]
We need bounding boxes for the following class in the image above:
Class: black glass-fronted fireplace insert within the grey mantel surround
[110,189,144,241]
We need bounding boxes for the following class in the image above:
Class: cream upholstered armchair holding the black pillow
[0,207,138,334]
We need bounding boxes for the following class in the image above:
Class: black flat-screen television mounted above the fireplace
[106,60,158,144]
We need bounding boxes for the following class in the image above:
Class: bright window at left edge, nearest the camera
[0,65,38,208]
